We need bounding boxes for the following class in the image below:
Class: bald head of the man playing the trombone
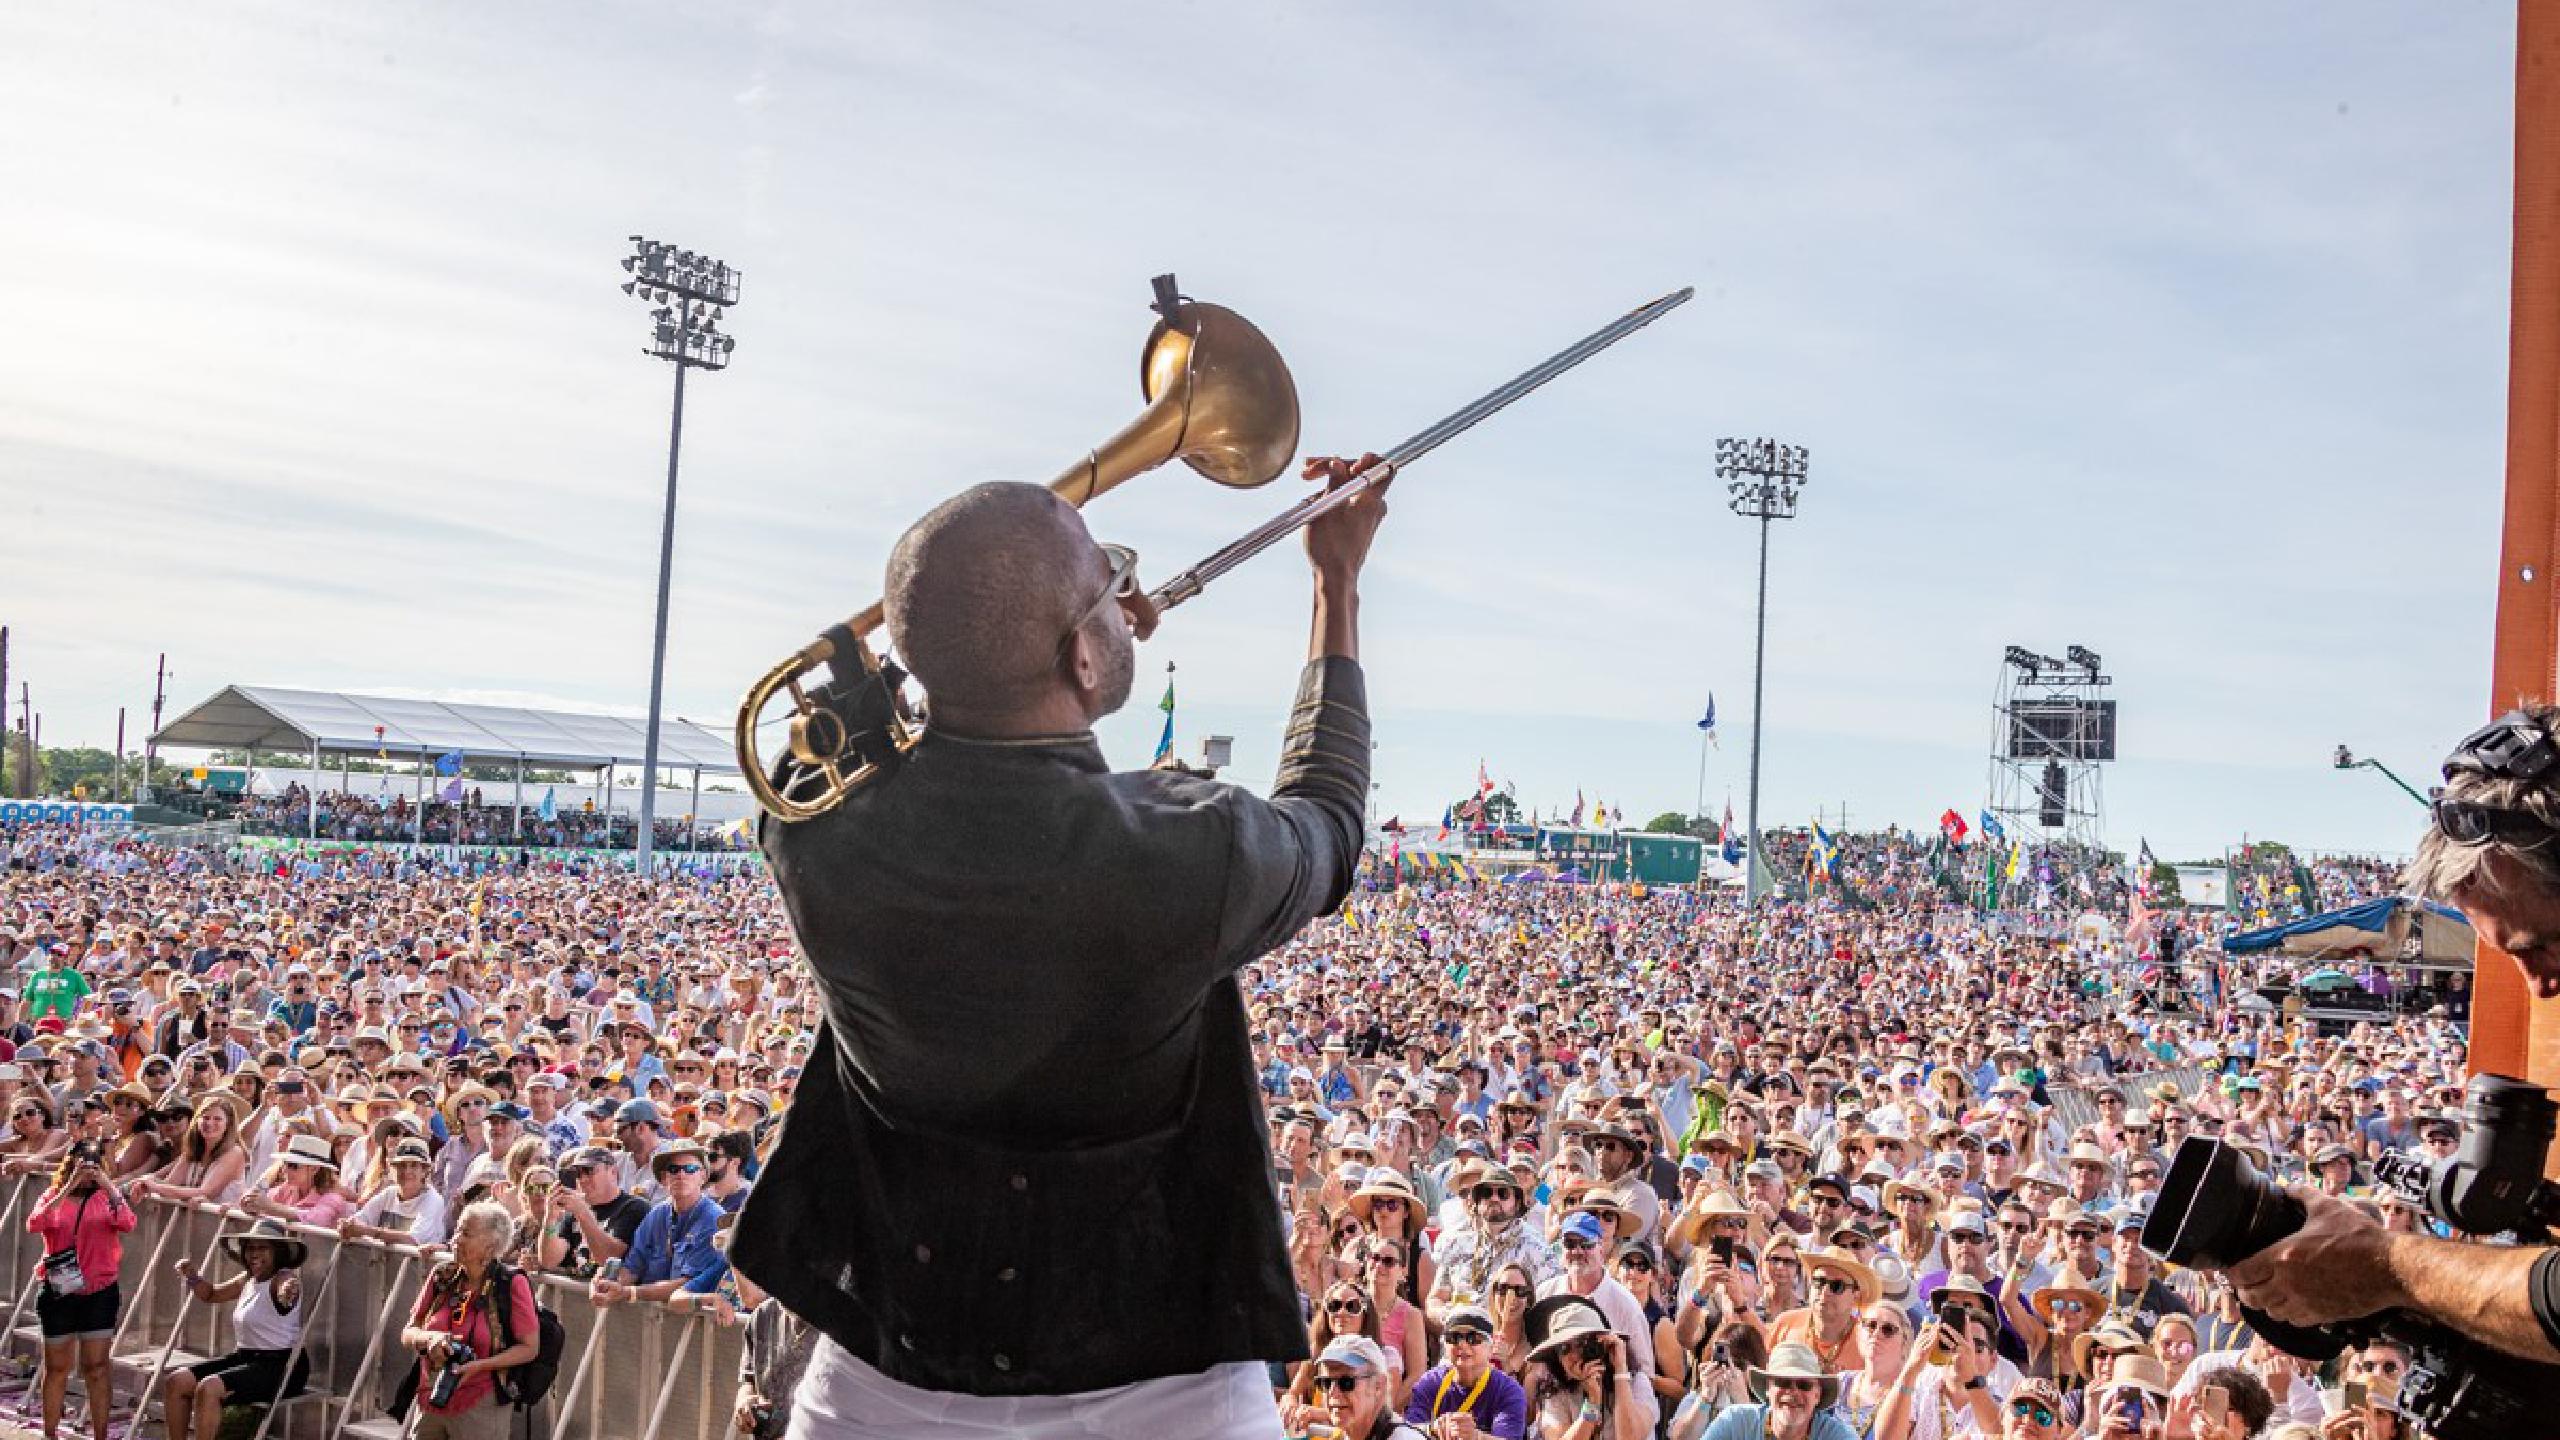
[886,484,1134,715]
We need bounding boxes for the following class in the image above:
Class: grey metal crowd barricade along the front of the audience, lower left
[0,1176,745,1440]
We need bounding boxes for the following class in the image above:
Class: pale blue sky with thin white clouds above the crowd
[0,3,2514,856]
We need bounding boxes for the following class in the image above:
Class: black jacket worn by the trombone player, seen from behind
[732,659,1370,1394]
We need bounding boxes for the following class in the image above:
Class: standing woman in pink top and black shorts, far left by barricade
[26,1140,133,1440]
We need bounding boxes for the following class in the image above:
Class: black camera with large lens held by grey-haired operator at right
[2143,1074,2560,1440]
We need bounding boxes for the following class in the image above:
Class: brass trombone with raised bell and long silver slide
[737,274,1692,822]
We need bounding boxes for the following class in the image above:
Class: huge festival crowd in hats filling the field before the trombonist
[0,825,2463,1440]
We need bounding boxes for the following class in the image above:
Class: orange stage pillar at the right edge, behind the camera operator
[2470,0,2560,1084]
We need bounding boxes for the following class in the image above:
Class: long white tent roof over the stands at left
[151,684,737,774]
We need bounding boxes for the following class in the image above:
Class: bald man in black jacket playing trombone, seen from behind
[732,461,1385,1440]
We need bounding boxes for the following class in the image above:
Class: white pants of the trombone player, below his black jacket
[788,1338,1280,1440]
